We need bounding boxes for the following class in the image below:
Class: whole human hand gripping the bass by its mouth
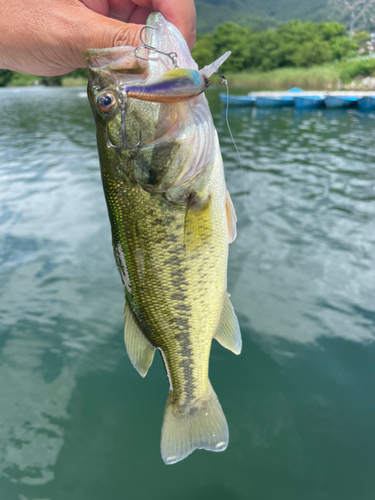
[0,0,195,76]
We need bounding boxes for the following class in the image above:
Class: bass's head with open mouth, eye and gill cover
[85,13,217,192]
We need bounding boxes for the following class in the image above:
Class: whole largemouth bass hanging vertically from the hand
[84,13,242,465]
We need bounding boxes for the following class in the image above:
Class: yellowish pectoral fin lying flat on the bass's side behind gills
[184,195,212,251]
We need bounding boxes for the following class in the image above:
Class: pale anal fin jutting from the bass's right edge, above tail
[215,293,242,354]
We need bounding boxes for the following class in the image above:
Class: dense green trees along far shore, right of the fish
[192,20,358,73]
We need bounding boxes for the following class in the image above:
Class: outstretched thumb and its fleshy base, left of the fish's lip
[0,0,142,76]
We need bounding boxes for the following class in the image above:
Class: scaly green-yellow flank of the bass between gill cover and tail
[103,134,227,409]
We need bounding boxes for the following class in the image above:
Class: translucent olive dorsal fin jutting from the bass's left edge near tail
[124,301,155,377]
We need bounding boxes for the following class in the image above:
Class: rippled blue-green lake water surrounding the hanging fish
[0,88,375,500]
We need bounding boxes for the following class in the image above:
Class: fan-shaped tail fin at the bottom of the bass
[161,384,229,465]
